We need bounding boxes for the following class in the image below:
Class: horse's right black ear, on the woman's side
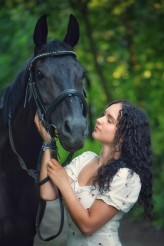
[63,14,79,47]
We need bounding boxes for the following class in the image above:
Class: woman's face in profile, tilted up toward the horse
[92,103,122,147]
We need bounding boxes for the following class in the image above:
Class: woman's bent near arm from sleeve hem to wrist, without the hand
[60,185,118,236]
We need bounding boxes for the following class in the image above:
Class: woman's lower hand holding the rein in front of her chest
[47,159,69,189]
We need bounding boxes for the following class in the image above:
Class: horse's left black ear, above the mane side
[33,15,48,48]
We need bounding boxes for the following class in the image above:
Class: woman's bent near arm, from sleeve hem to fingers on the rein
[48,160,118,236]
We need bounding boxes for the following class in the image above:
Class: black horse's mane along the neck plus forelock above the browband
[0,40,72,125]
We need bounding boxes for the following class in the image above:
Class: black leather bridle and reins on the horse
[8,51,87,241]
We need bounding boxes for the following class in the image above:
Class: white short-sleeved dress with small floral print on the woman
[65,151,141,246]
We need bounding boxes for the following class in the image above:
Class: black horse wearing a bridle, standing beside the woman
[0,15,87,246]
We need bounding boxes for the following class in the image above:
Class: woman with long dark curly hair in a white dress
[35,101,152,246]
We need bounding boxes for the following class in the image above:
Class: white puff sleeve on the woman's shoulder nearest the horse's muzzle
[65,151,97,181]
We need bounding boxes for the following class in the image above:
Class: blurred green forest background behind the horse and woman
[0,0,164,246]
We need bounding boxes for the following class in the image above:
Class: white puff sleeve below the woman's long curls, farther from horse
[97,168,141,213]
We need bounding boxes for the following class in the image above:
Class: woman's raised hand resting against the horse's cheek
[34,113,51,143]
